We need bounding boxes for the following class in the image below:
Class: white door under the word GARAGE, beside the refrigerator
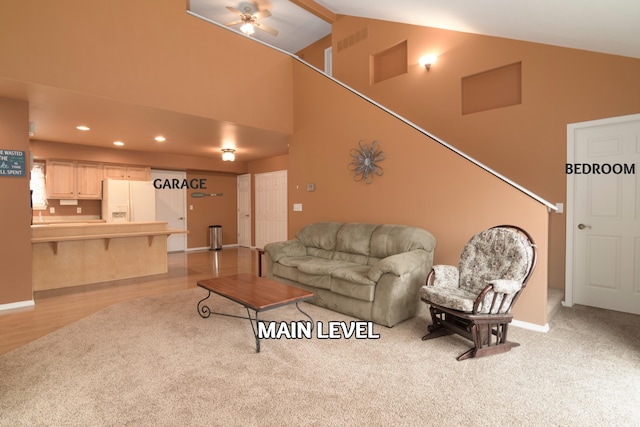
[151,169,187,252]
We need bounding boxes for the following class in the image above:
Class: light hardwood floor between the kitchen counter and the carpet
[0,247,258,354]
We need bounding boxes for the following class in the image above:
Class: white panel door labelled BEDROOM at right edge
[566,115,640,314]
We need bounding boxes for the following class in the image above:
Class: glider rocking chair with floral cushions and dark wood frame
[420,225,537,360]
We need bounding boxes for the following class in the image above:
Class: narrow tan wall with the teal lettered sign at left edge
[0,98,33,305]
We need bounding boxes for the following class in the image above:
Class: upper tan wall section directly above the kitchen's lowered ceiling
[0,0,292,132]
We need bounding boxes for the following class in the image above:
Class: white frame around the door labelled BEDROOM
[562,114,640,307]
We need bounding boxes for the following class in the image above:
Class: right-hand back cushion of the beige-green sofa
[371,224,436,258]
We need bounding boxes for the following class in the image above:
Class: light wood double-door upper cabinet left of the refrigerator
[46,160,102,200]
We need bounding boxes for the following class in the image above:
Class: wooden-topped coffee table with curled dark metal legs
[197,274,313,353]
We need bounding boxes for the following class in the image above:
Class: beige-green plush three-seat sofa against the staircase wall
[264,222,436,327]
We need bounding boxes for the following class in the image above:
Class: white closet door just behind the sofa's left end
[255,171,287,248]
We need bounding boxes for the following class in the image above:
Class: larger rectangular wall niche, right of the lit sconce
[462,62,522,115]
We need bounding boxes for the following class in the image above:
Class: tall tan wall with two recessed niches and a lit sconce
[333,17,640,288]
